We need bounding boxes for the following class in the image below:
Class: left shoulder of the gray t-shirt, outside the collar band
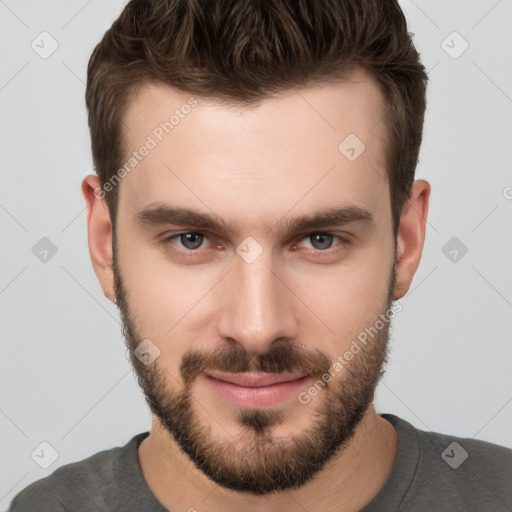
[8,440,130,512]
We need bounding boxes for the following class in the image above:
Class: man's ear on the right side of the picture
[395,180,430,300]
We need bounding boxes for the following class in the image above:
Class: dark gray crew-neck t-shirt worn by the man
[9,414,512,512]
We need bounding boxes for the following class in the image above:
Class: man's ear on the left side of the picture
[82,174,115,302]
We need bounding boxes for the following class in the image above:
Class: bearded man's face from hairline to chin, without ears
[114,72,395,494]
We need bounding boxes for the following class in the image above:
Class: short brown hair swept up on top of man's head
[86,0,428,236]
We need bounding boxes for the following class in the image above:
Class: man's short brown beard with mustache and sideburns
[113,240,396,495]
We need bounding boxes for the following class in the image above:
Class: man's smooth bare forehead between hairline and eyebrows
[119,71,388,229]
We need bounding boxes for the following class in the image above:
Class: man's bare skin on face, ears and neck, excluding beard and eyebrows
[82,71,430,512]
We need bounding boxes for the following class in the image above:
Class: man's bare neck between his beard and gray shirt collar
[138,405,398,512]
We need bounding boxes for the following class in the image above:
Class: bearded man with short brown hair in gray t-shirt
[11,0,512,512]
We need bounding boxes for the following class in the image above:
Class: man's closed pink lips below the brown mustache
[200,371,311,409]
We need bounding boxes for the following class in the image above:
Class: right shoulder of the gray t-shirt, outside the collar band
[401,418,512,512]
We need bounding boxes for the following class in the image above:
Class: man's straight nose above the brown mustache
[217,251,298,354]
